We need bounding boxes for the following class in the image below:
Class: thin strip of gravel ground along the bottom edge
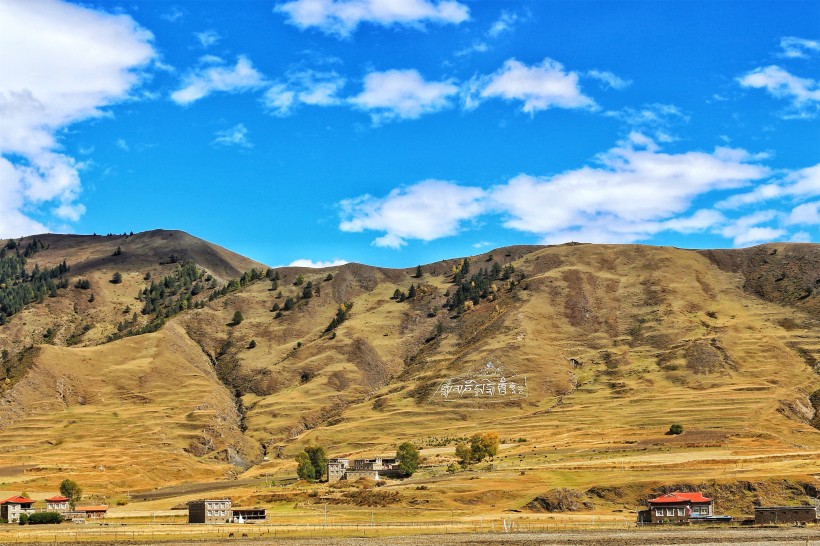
[14,527,820,546]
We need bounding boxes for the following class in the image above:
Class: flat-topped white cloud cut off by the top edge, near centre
[276,0,470,37]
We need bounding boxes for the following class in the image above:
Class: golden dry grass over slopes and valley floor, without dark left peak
[0,239,820,523]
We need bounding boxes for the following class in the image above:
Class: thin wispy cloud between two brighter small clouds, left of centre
[262,70,347,116]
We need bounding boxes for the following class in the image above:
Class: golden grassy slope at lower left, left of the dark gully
[0,325,255,491]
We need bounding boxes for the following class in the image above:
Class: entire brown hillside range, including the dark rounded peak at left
[0,232,820,512]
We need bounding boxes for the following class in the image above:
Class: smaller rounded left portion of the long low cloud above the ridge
[339,180,485,248]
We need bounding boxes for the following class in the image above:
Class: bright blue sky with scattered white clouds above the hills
[0,0,820,267]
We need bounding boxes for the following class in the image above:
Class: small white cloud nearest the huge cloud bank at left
[171,55,265,105]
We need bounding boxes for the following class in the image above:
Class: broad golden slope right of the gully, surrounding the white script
[232,241,820,460]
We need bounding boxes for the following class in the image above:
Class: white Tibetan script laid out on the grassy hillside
[433,362,527,402]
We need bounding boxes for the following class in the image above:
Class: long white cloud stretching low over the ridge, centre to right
[340,134,780,248]
